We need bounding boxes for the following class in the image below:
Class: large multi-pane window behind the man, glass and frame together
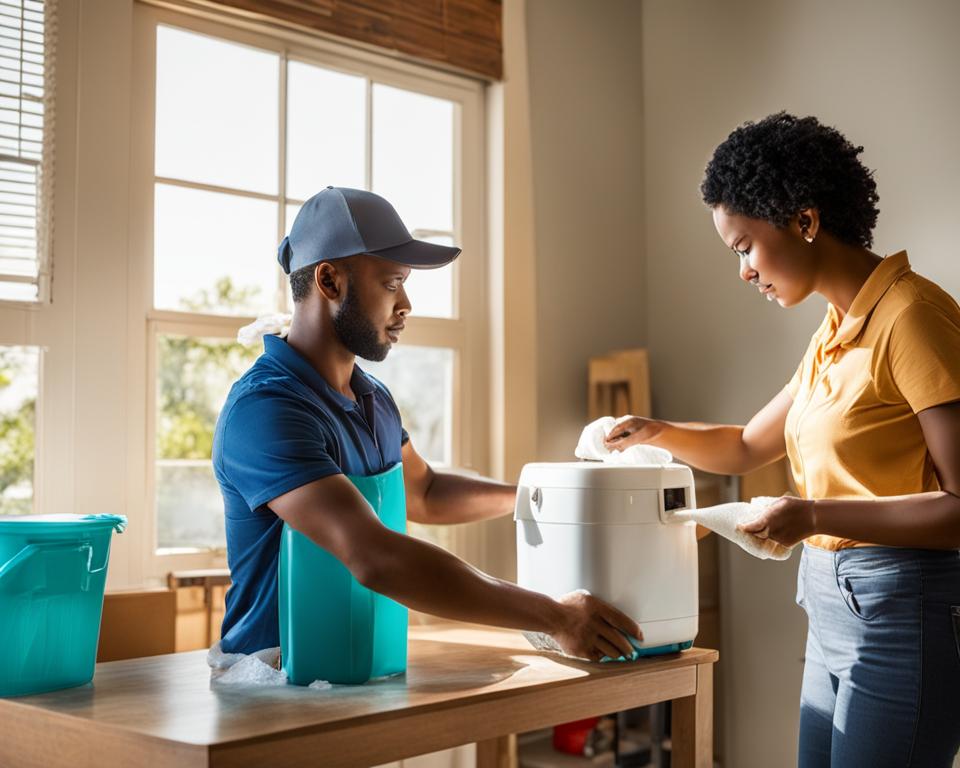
[134,6,486,571]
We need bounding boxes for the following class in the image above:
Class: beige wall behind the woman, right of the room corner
[640,0,960,768]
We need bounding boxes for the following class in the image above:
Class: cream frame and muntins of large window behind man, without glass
[128,2,490,578]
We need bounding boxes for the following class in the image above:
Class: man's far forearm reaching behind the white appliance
[419,472,517,524]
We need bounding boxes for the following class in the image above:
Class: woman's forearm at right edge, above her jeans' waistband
[813,491,960,549]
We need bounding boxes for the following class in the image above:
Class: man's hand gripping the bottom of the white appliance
[551,589,643,661]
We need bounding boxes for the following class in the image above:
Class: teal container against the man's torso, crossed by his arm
[278,464,407,685]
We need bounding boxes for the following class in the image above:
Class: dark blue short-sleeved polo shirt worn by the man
[213,336,407,653]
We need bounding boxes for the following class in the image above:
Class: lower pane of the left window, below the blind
[0,347,40,515]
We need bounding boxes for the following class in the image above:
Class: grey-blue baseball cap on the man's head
[277,187,460,275]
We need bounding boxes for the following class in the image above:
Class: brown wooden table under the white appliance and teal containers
[0,624,717,768]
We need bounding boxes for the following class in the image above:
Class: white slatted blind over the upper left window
[0,0,56,301]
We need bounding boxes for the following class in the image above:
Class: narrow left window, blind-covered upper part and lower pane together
[0,0,55,515]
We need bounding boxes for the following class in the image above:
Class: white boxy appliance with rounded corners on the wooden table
[514,461,699,656]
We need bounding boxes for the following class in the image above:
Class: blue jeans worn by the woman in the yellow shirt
[797,546,960,768]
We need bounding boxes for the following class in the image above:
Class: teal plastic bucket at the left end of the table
[0,515,127,696]
